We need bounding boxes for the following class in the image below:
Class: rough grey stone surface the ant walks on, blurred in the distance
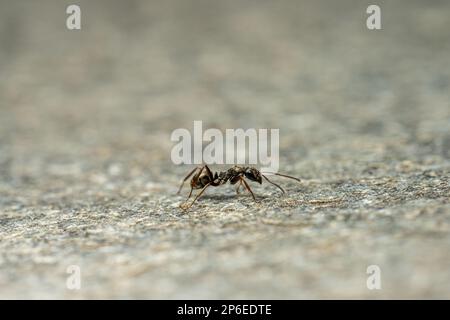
[0,0,450,299]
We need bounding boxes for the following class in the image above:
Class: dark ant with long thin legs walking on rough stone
[177,165,300,210]
